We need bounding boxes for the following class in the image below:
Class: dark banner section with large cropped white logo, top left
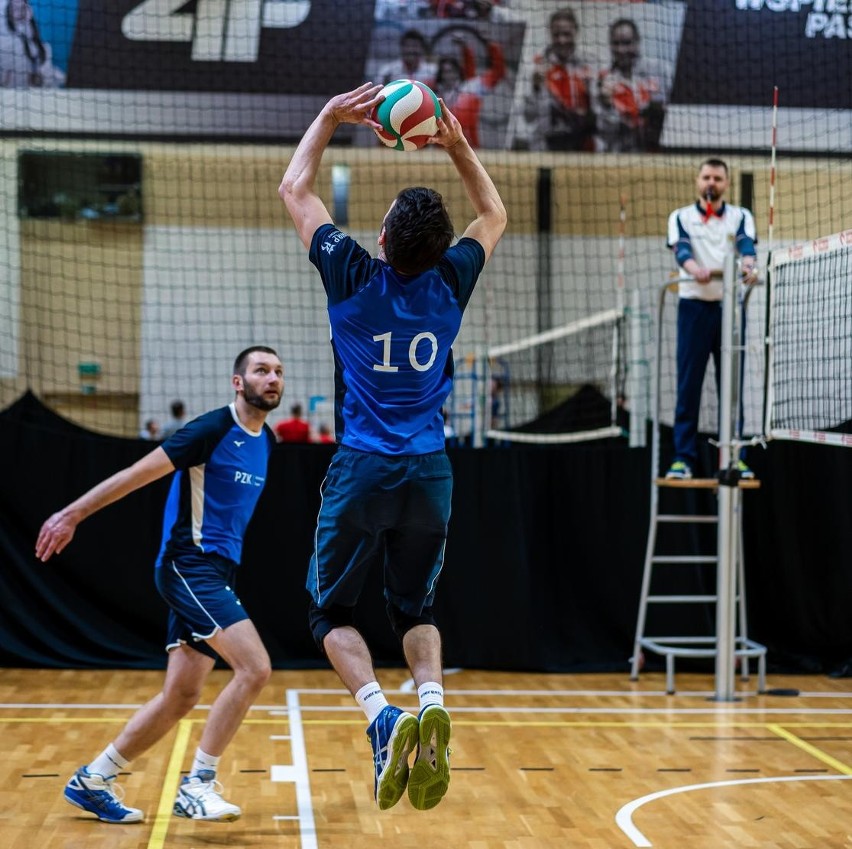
[67,0,374,95]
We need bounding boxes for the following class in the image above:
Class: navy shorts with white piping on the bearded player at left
[154,554,249,657]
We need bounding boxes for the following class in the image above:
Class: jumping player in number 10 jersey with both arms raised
[278,83,506,810]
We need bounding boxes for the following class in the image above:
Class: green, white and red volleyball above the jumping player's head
[373,80,441,151]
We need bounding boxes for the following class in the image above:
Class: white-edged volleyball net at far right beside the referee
[765,230,852,447]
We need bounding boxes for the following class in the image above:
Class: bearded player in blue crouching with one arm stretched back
[36,345,284,823]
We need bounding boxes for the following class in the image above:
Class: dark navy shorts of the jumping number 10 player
[307,446,453,616]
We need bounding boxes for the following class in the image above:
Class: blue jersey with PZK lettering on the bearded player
[157,404,275,567]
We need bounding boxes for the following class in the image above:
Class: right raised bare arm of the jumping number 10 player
[430,100,506,260]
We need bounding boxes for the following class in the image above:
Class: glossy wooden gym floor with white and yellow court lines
[0,669,852,849]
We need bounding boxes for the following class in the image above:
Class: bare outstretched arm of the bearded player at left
[35,446,175,561]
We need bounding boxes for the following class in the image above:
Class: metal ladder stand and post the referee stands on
[630,246,766,701]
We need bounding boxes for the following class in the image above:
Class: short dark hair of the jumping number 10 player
[385,186,454,274]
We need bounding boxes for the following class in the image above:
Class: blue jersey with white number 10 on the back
[310,224,485,455]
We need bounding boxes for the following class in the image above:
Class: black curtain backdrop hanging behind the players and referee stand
[0,394,852,674]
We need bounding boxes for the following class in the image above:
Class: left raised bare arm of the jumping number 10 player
[278,83,382,248]
